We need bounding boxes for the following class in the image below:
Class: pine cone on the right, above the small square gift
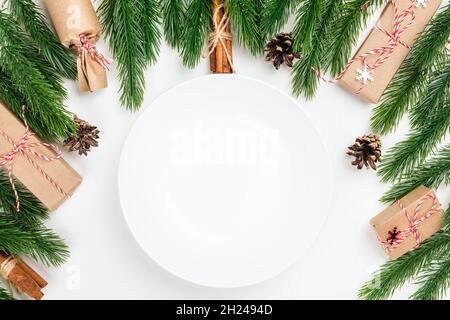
[347,134,381,170]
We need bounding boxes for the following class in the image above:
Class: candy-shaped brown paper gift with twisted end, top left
[45,0,108,92]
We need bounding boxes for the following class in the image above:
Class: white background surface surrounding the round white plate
[29,1,450,299]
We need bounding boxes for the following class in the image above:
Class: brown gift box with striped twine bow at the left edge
[0,103,81,211]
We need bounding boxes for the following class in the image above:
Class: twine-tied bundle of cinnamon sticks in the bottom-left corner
[0,252,47,300]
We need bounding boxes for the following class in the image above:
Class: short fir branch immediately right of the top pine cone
[292,0,326,53]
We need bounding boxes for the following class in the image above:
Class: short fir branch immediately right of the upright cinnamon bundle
[225,0,264,56]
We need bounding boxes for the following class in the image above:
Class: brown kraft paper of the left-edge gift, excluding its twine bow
[0,103,82,211]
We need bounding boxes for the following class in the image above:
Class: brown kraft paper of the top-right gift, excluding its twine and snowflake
[340,0,442,103]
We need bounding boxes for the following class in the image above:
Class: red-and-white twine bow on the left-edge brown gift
[0,106,69,212]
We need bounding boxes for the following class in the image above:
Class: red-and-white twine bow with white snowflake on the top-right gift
[312,0,418,94]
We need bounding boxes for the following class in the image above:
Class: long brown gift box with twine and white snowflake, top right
[338,0,442,103]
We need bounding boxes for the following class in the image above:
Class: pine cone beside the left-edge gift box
[64,114,100,156]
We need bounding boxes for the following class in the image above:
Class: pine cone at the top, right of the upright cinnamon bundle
[265,32,300,70]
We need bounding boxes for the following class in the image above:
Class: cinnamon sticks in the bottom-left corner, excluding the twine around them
[0,252,47,300]
